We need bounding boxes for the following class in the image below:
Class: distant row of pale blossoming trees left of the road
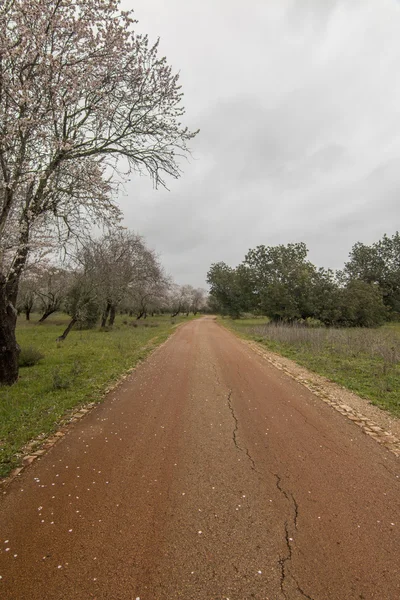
[16,229,206,340]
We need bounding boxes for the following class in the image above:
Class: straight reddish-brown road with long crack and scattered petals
[0,318,400,600]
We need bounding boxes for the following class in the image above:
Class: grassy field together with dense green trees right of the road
[208,232,400,416]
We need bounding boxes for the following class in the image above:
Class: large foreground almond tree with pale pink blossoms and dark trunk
[0,0,197,384]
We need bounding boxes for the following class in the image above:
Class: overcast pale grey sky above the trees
[119,0,400,287]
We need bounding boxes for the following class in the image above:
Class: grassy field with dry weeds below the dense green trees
[221,319,400,416]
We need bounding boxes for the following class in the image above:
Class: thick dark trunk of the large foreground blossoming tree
[0,275,20,385]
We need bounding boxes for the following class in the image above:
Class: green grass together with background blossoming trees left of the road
[0,220,206,477]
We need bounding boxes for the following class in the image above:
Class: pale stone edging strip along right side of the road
[247,340,400,456]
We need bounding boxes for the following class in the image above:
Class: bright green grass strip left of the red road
[0,313,194,477]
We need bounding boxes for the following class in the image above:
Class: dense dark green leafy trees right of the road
[207,232,400,327]
